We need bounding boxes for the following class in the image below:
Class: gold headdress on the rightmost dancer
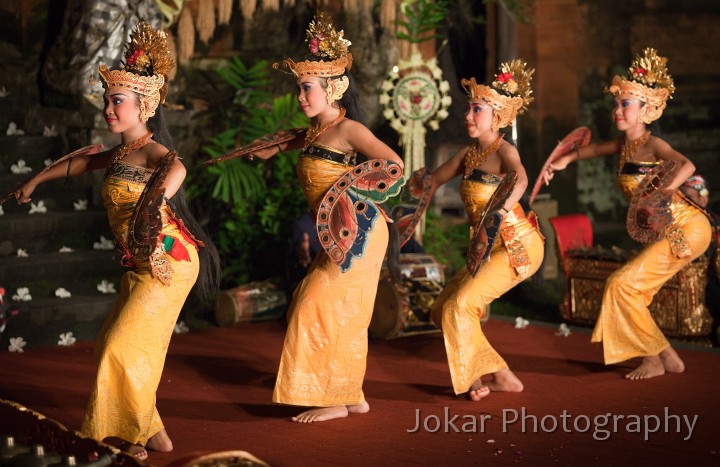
[605,47,675,123]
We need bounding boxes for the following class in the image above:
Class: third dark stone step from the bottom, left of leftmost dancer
[0,209,112,254]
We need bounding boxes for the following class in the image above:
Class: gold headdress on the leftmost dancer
[98,22,175,122]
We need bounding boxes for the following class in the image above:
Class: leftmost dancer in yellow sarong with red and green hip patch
[6,23,219,459]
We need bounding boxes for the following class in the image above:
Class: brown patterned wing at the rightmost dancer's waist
[627,161,675,243]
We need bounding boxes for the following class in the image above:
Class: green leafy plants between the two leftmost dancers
[188,57,307,285]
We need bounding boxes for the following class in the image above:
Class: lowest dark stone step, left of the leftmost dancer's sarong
[0,294,117,351]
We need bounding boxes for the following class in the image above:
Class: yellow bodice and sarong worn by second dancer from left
[273,146,388,407]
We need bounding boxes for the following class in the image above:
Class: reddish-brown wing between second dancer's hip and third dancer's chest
[390,167,434,247]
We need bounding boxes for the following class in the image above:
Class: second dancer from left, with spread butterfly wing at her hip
[242,12,403,423]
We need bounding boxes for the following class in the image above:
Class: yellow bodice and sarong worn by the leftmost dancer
[81,162,200,445]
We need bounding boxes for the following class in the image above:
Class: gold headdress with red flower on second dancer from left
[273,11,352,103]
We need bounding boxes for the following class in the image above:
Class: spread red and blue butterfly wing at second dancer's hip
[317,159,405,272]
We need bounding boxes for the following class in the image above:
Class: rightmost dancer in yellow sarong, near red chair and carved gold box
[541,48,711,379]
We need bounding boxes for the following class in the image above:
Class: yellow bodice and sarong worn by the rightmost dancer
[592,162,712,365]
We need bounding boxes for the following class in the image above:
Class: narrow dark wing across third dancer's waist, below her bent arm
[465,171,517,276]
